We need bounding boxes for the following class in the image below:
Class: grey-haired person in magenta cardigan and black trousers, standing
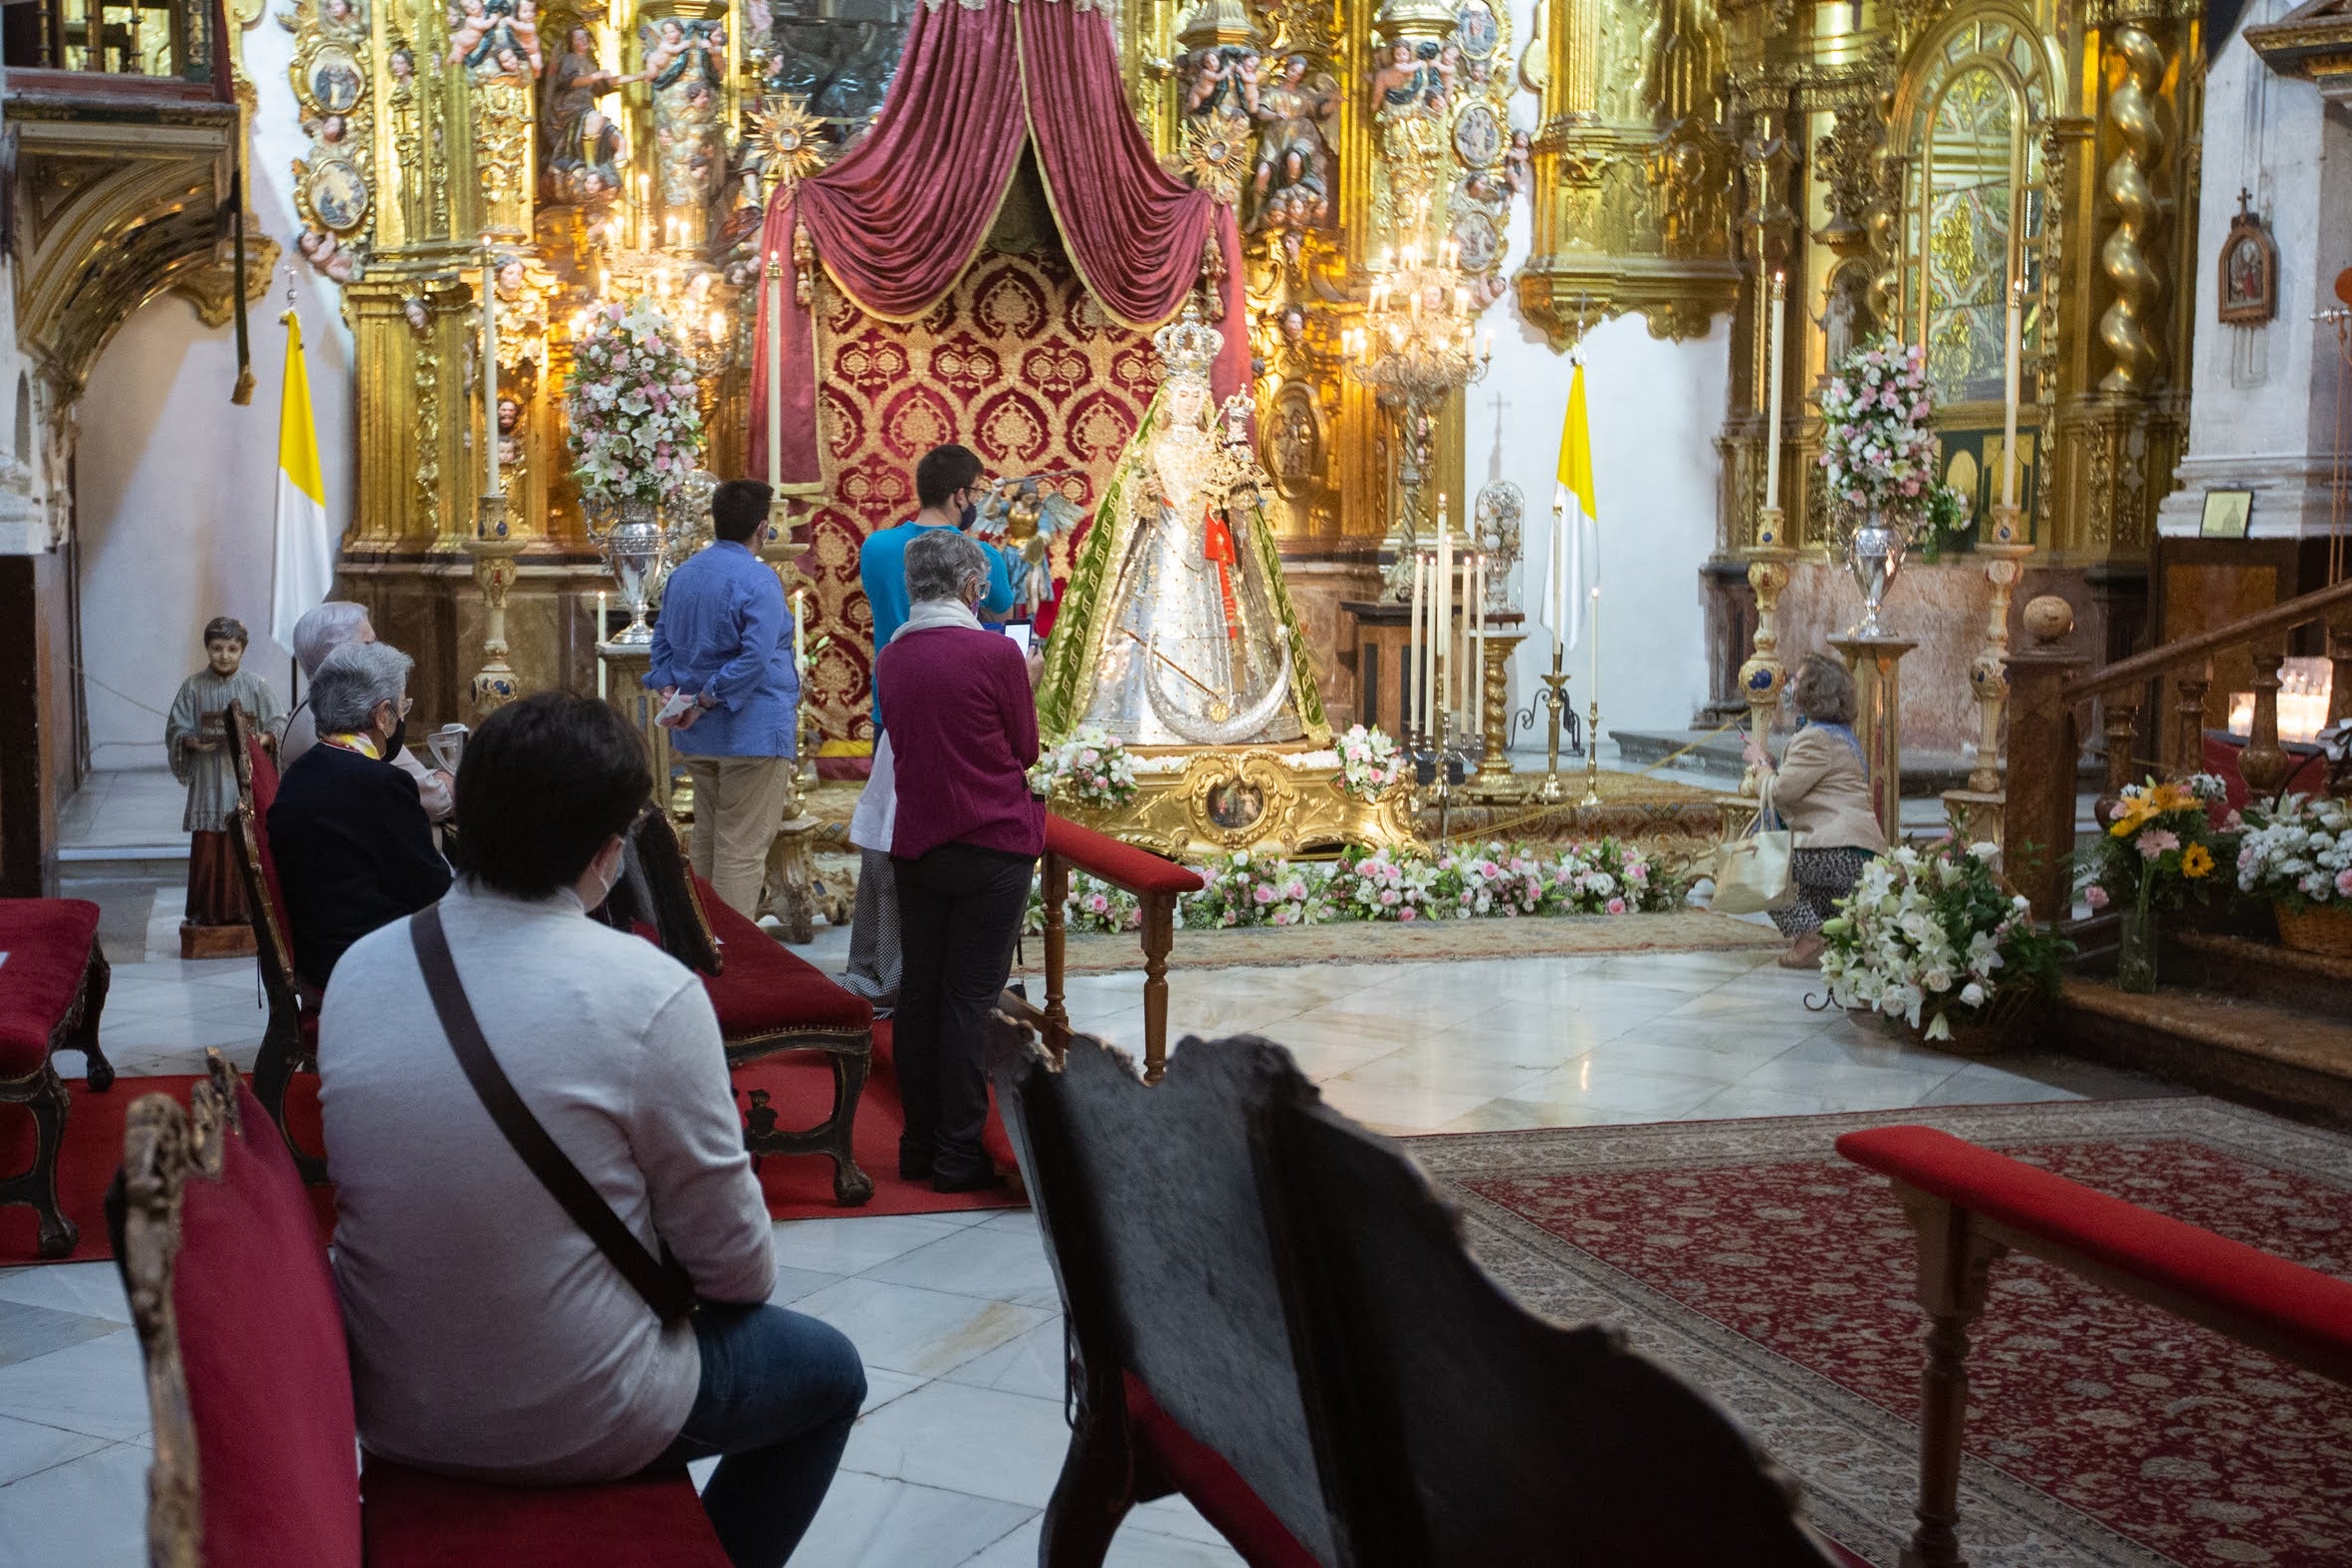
[875,529,1045,1192]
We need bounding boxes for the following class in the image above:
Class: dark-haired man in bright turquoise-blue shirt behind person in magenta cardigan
[842,447,1014,1013]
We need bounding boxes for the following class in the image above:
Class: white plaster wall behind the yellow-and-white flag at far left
[76,19,353,769]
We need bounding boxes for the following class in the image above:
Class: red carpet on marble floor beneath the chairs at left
[0,1020,1021,1267]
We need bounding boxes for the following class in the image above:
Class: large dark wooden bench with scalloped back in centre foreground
[990,1017,1837,1568]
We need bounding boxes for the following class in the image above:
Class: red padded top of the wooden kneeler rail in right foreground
[1837,1126,2352,1347]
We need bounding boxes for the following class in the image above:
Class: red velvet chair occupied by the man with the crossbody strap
[116,1051,727,1568]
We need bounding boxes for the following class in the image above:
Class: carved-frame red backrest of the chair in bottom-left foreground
[109,1051,362,1568]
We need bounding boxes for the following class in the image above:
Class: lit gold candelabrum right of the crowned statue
[1340,220,1494,601]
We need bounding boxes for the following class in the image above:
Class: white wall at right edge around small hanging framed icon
[2157,0,2352,539]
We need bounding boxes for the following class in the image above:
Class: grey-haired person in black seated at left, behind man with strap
[268,642,449,985]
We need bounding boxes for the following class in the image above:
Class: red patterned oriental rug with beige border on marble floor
[1411,1098,2352,1568]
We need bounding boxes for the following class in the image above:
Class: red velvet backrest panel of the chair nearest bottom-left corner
[171,1086,359,1568]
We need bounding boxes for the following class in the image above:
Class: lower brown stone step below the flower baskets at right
[2041,976,2352,1131]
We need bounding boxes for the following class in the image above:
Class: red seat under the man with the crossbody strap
[354,1456,727,1568]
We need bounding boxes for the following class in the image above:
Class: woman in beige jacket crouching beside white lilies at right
[1748,653,1886,969]
